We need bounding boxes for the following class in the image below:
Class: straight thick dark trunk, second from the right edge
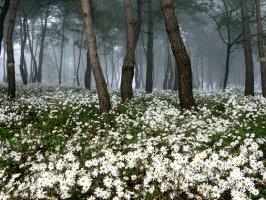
[240,0,254,96]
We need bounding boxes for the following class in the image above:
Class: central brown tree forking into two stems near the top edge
[120,0,143,102]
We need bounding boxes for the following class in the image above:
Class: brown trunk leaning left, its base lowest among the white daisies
[81,0,111,125]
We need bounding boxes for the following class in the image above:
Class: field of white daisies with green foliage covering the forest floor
[0,85,266,200]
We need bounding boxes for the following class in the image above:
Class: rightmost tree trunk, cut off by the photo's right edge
[255,0,266,98]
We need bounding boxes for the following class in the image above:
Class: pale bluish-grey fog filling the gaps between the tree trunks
[0,0,261,90]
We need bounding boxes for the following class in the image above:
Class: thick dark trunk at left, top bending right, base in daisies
[7,0,20,99]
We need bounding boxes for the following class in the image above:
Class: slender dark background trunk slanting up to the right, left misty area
[37,5,49,83]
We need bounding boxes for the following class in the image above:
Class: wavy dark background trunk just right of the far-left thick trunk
[19,14,28,85]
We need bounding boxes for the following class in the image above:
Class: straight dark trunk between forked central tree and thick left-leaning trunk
[146,0,153,93]
